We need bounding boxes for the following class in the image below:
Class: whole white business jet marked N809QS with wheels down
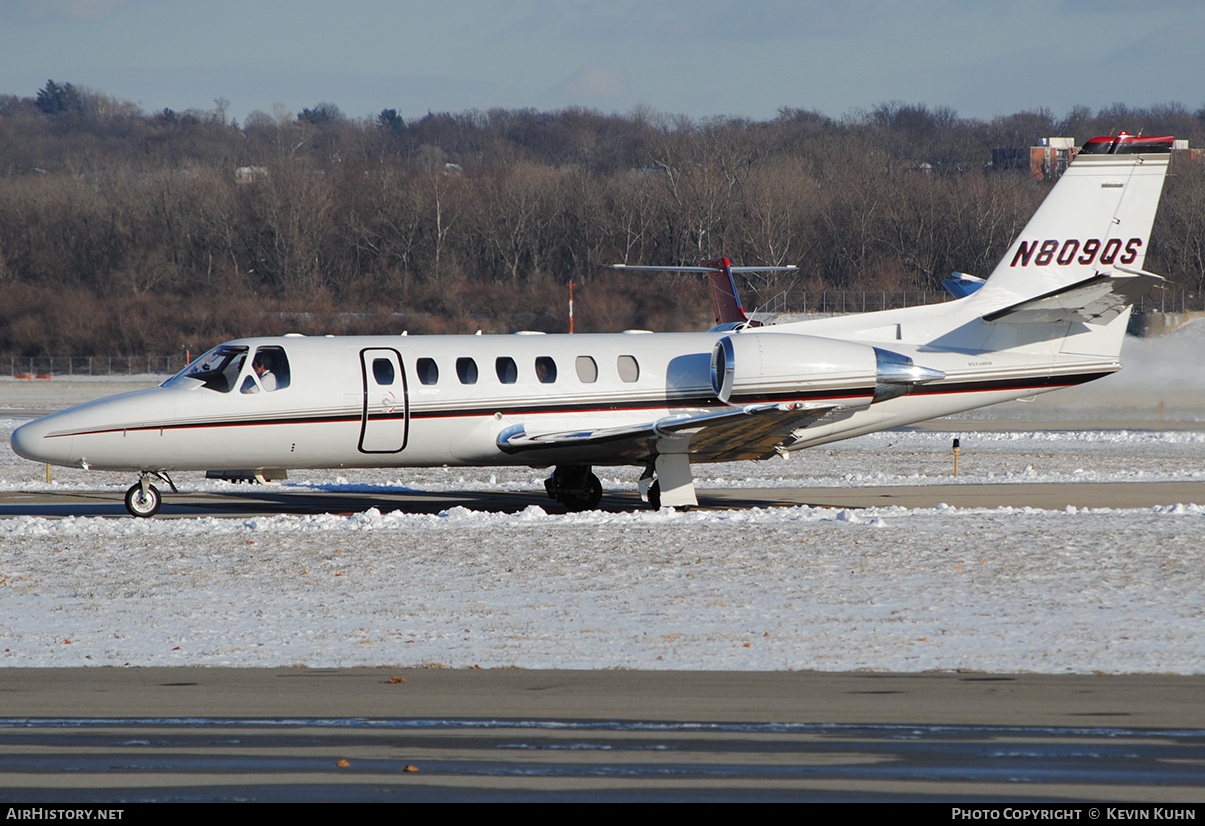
[12,133,1172,516]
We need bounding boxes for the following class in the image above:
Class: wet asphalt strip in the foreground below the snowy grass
[0,668,1205,800]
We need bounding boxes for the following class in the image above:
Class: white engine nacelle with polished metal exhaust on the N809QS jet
[711,333,946,404]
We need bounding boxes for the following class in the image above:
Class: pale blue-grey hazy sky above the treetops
[0,0,1205,121]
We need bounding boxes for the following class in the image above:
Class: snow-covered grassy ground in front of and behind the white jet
[0,324,1205,674]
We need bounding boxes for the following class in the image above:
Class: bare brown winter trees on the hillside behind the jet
[0,81,1205,356]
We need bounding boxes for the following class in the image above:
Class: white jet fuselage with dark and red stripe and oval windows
[12,325,1117,471]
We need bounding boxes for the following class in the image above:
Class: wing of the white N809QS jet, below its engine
[498,402,844,464]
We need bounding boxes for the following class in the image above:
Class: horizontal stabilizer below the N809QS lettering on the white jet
[983,270,1163,324]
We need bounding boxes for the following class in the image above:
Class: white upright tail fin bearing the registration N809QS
[977,133,1172,308]
